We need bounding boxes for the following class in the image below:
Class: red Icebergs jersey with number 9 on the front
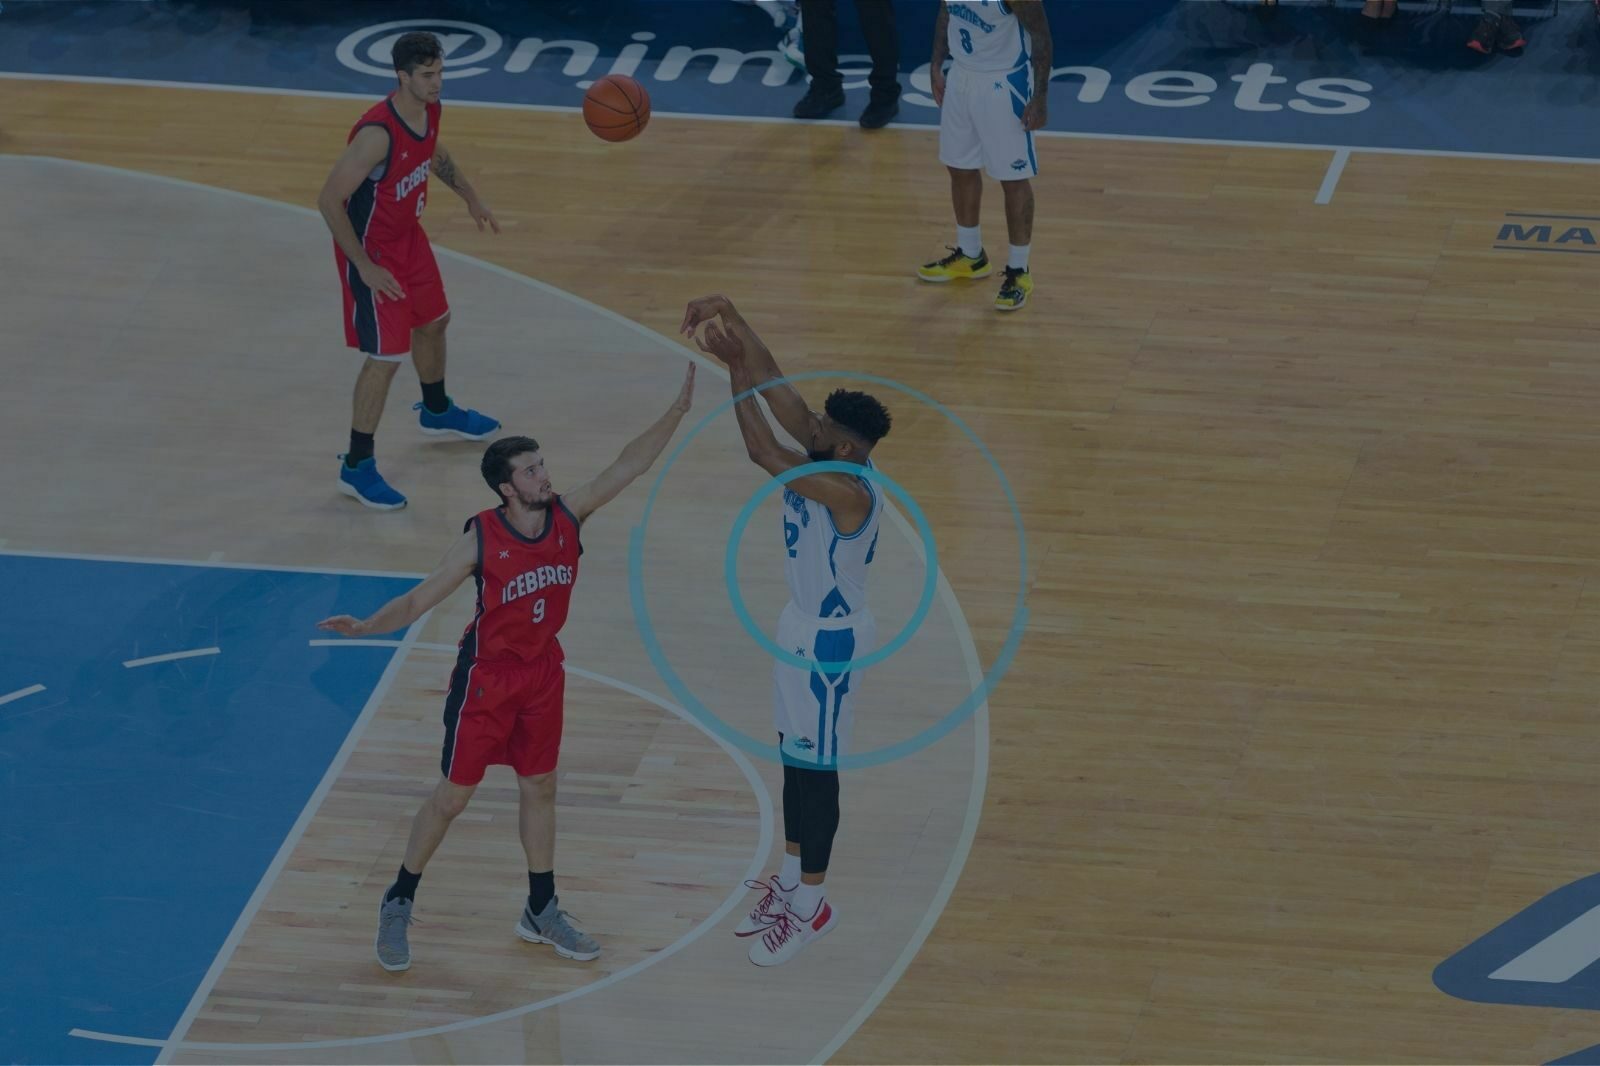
[459,496,584,663]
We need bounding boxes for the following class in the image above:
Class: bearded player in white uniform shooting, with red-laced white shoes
[682,296,890,967]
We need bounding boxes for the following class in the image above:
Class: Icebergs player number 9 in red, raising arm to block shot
[317,363,694,970]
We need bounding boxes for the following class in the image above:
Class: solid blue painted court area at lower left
[0,554,414,1063]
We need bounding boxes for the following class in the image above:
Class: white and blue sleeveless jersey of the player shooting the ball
[784,461,883,618]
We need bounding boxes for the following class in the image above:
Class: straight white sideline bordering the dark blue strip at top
[0,70,1600,166]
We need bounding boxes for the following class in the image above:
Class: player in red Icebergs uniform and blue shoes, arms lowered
[317,34,499,511]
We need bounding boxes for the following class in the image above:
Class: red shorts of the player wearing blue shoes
[333,226,450,359]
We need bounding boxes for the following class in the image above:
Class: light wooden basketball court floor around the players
[0,82,1600,1063]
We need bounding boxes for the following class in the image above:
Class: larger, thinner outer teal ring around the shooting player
[627,370,1027,770]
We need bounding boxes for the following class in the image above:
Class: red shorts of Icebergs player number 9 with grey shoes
[440,648,566,784]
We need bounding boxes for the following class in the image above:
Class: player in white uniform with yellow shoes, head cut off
[917,0,1051,311]
